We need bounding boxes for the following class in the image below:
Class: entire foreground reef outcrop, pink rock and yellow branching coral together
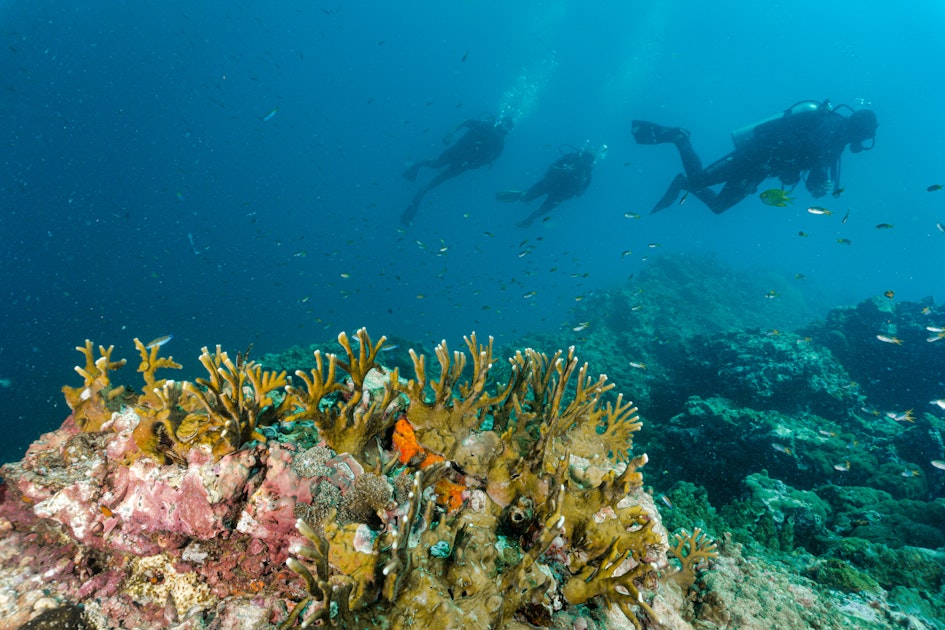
[0,329,672,629]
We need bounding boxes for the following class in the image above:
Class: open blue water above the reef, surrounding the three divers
[0,0,945,460]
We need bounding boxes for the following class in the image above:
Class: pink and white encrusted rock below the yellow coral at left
[0,409,354,630]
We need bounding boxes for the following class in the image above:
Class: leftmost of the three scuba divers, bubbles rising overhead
[400,116,514,225]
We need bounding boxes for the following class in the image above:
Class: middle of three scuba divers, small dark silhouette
[495,149,597,227]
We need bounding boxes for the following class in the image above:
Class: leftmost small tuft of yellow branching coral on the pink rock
[62,339,126,431]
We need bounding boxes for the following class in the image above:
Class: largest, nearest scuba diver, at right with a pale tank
[631,101,878,214]
